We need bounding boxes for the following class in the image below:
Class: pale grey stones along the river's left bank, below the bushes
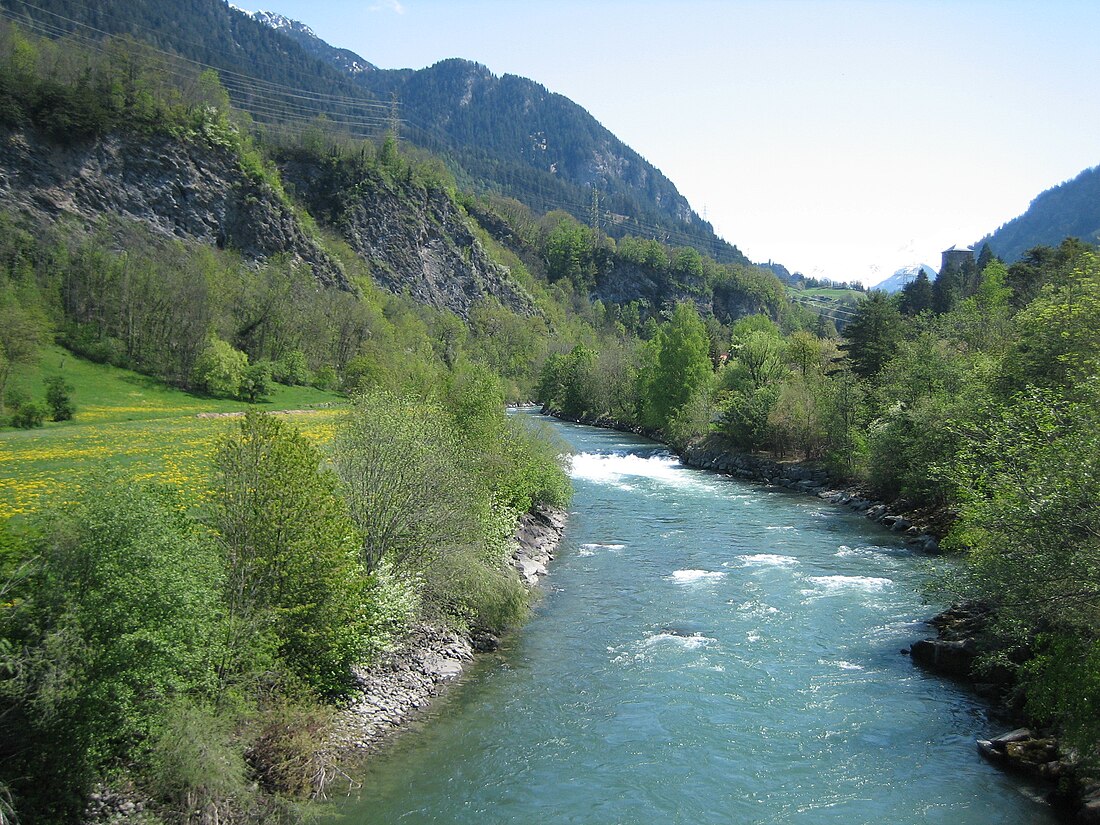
[325,507,567,759]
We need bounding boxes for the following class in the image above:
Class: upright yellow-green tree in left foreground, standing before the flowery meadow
[212,410,370,695]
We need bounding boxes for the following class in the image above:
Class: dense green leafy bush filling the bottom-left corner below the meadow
[0,477,221,821]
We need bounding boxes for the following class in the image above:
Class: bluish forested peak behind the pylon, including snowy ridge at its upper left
[237,5,749,263]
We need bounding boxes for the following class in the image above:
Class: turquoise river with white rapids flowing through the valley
[327,415,1056,825]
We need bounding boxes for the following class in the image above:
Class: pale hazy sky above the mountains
[247,0,1100,284]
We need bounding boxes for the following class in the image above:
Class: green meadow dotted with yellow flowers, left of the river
[0,348,347,519]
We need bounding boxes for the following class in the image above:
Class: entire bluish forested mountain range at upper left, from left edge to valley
[0,0,749,264]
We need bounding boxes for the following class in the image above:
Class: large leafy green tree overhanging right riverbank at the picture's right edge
[947,387,1100,759]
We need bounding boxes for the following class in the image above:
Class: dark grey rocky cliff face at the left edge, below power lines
[0,124,350,289]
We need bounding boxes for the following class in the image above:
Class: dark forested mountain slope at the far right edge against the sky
[975,166,1100,263]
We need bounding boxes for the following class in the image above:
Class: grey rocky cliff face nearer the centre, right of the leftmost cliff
[282,162,535,319]
